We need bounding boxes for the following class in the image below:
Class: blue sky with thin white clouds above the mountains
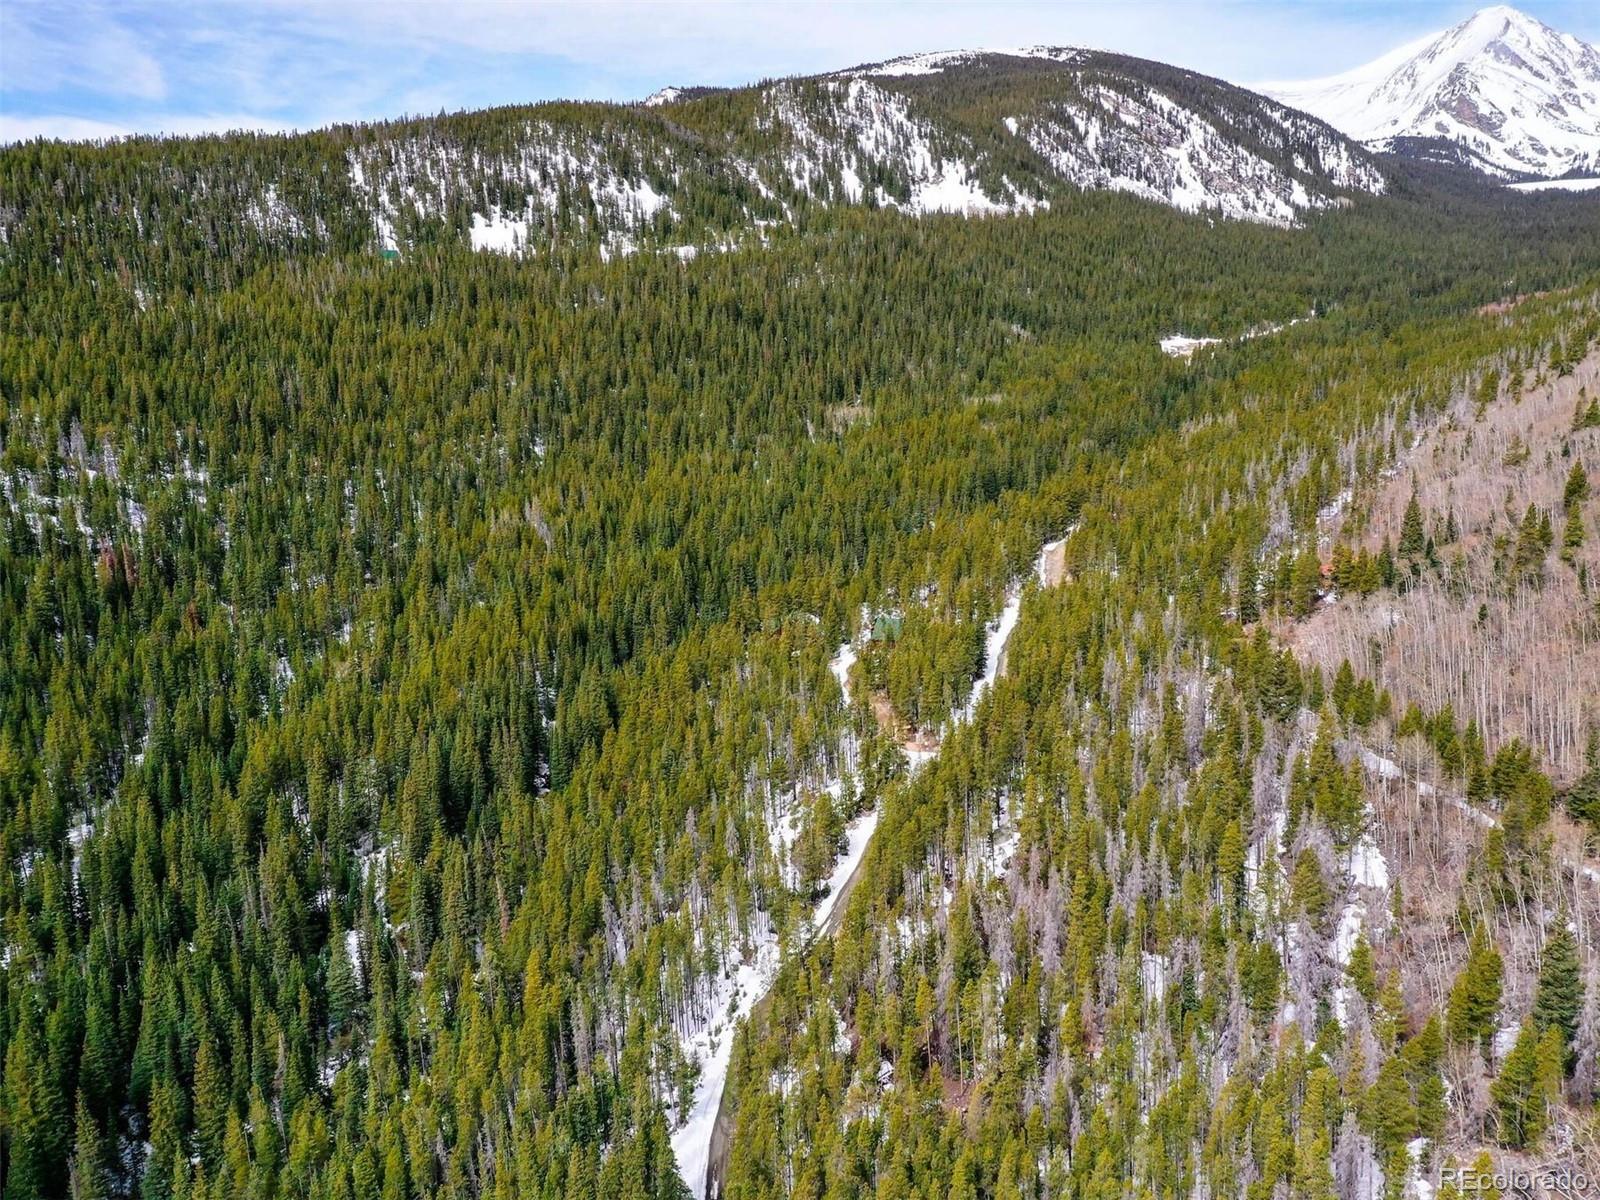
[9,0,1600,141]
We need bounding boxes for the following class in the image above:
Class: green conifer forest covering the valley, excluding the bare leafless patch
[0,61,1600,1200]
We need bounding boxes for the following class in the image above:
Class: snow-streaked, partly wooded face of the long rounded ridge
[340,48,1384,250]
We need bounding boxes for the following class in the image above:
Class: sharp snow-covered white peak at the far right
[1259,5,1600,178]
